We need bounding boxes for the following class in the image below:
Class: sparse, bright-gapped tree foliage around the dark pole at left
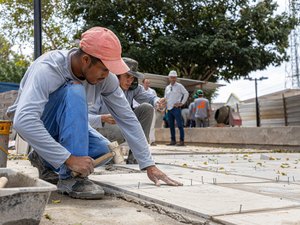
[0,0,78,82]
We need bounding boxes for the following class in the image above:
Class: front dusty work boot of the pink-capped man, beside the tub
[57,177,104,199]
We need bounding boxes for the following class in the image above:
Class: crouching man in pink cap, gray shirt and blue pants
[7,27,180,199]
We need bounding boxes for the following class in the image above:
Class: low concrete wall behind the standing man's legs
[155,127,300,147]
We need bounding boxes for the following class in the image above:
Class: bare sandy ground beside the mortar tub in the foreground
[40,192,182,225]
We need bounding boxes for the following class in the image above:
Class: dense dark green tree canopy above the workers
[67,0,297,81]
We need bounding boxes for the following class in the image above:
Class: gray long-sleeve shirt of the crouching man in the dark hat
[89,84,160,128]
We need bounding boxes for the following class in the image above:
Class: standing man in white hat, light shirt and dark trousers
[165,70,189,146]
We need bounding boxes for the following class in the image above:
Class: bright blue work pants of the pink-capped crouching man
[41,82,109,179]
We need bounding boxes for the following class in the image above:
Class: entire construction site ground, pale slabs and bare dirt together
[7,145,300,225]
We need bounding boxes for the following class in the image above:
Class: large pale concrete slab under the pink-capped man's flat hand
[91,169,300,218]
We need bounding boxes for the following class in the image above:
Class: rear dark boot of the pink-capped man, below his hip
[28,151,58,185]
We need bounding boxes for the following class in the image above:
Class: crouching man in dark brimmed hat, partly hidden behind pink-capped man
[89,57,166,164]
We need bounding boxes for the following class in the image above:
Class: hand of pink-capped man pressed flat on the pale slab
[146,166,183,186]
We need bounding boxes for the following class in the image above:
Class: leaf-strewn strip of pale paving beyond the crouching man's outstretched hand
[154,153,300,182]
